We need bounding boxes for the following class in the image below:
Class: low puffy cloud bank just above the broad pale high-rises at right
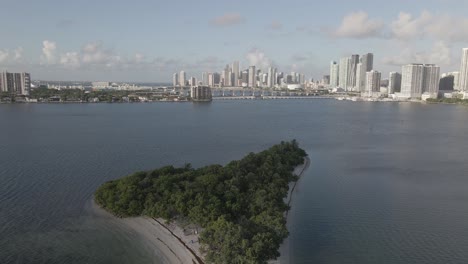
[382,41,453,66]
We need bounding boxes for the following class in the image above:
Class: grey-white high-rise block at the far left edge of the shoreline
[0,72,31,95]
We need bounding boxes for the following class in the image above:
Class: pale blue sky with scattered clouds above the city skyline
[0,0,468,82]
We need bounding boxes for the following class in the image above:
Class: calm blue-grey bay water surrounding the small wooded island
[0,100,468,263]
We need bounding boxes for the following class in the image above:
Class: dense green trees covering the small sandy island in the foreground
[95,140,307,263]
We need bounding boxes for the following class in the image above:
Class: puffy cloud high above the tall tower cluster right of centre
[332,11,385,38]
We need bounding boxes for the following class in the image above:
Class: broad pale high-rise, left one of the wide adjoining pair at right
[401,64,424,98]
